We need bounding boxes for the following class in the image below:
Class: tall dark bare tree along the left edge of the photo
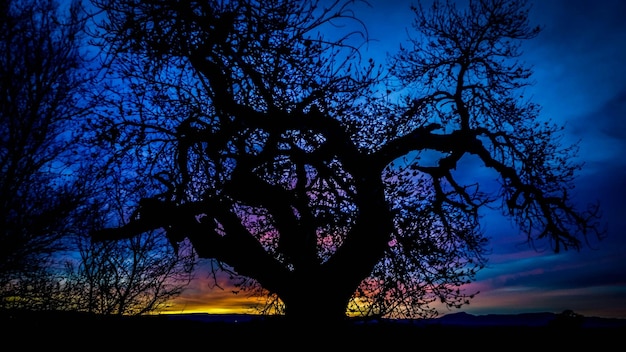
[0,1,94,306]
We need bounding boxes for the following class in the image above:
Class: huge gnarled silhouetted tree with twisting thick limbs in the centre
[94,0,602,319]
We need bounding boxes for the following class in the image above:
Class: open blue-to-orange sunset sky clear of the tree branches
[165,0,626,318]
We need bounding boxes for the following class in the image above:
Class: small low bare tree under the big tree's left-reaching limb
[63,231,196,315]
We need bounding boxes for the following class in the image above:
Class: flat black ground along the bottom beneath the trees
[0,312,626,351]
